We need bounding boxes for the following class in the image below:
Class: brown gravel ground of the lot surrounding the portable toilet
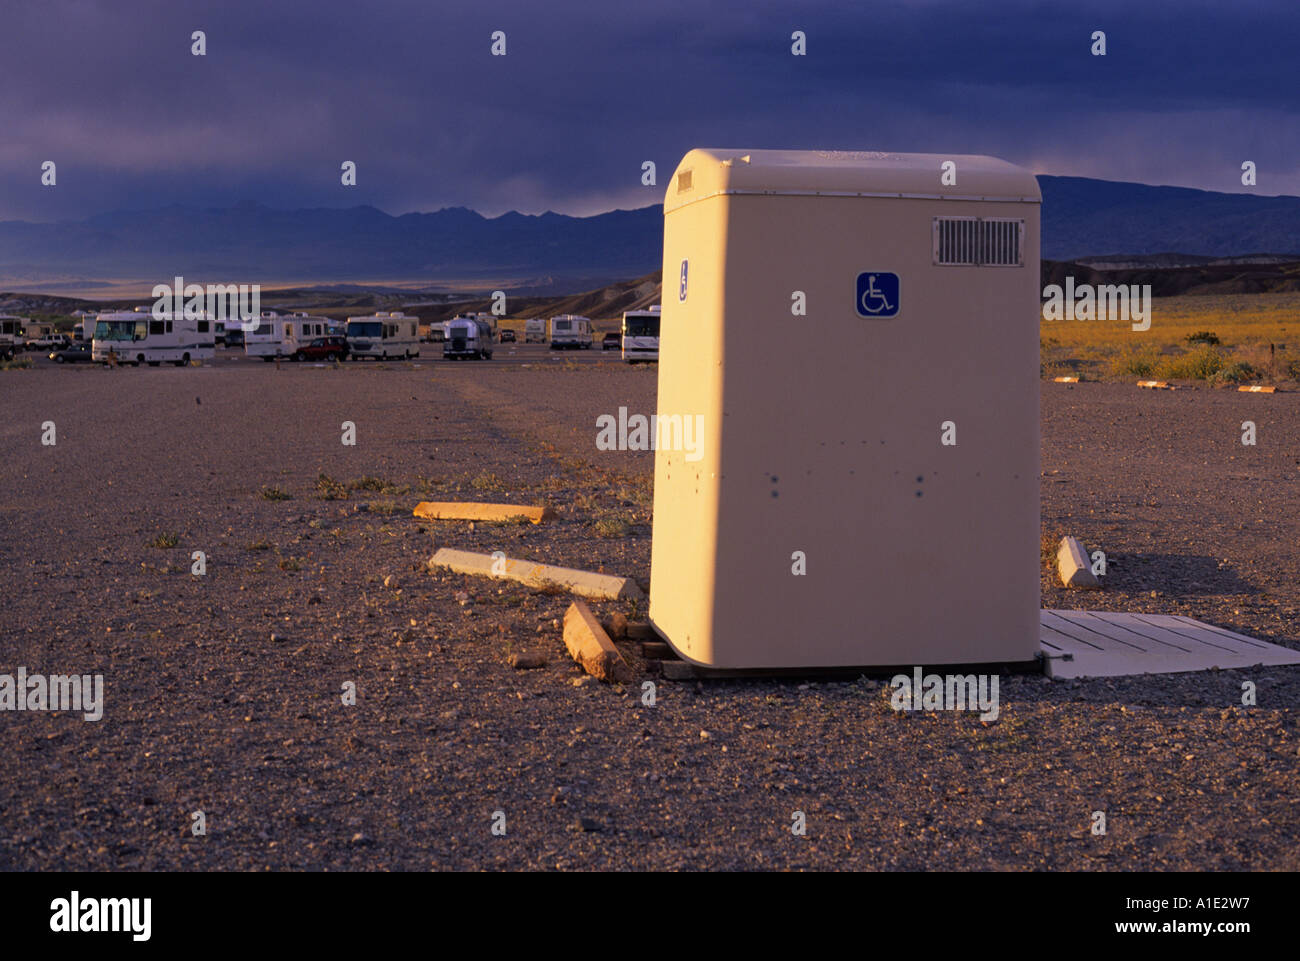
[0,363,1300,870]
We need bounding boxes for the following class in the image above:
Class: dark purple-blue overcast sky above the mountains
[0,0,1300,221]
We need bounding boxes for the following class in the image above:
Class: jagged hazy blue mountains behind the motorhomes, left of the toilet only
[0,204,663,290]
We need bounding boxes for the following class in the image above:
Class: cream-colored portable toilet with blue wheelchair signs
[650,150,1040,668]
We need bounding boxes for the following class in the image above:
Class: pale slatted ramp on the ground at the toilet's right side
[1039,610,1300,678]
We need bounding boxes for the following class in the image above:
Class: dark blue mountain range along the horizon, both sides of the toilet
[0,176,1300,287]
